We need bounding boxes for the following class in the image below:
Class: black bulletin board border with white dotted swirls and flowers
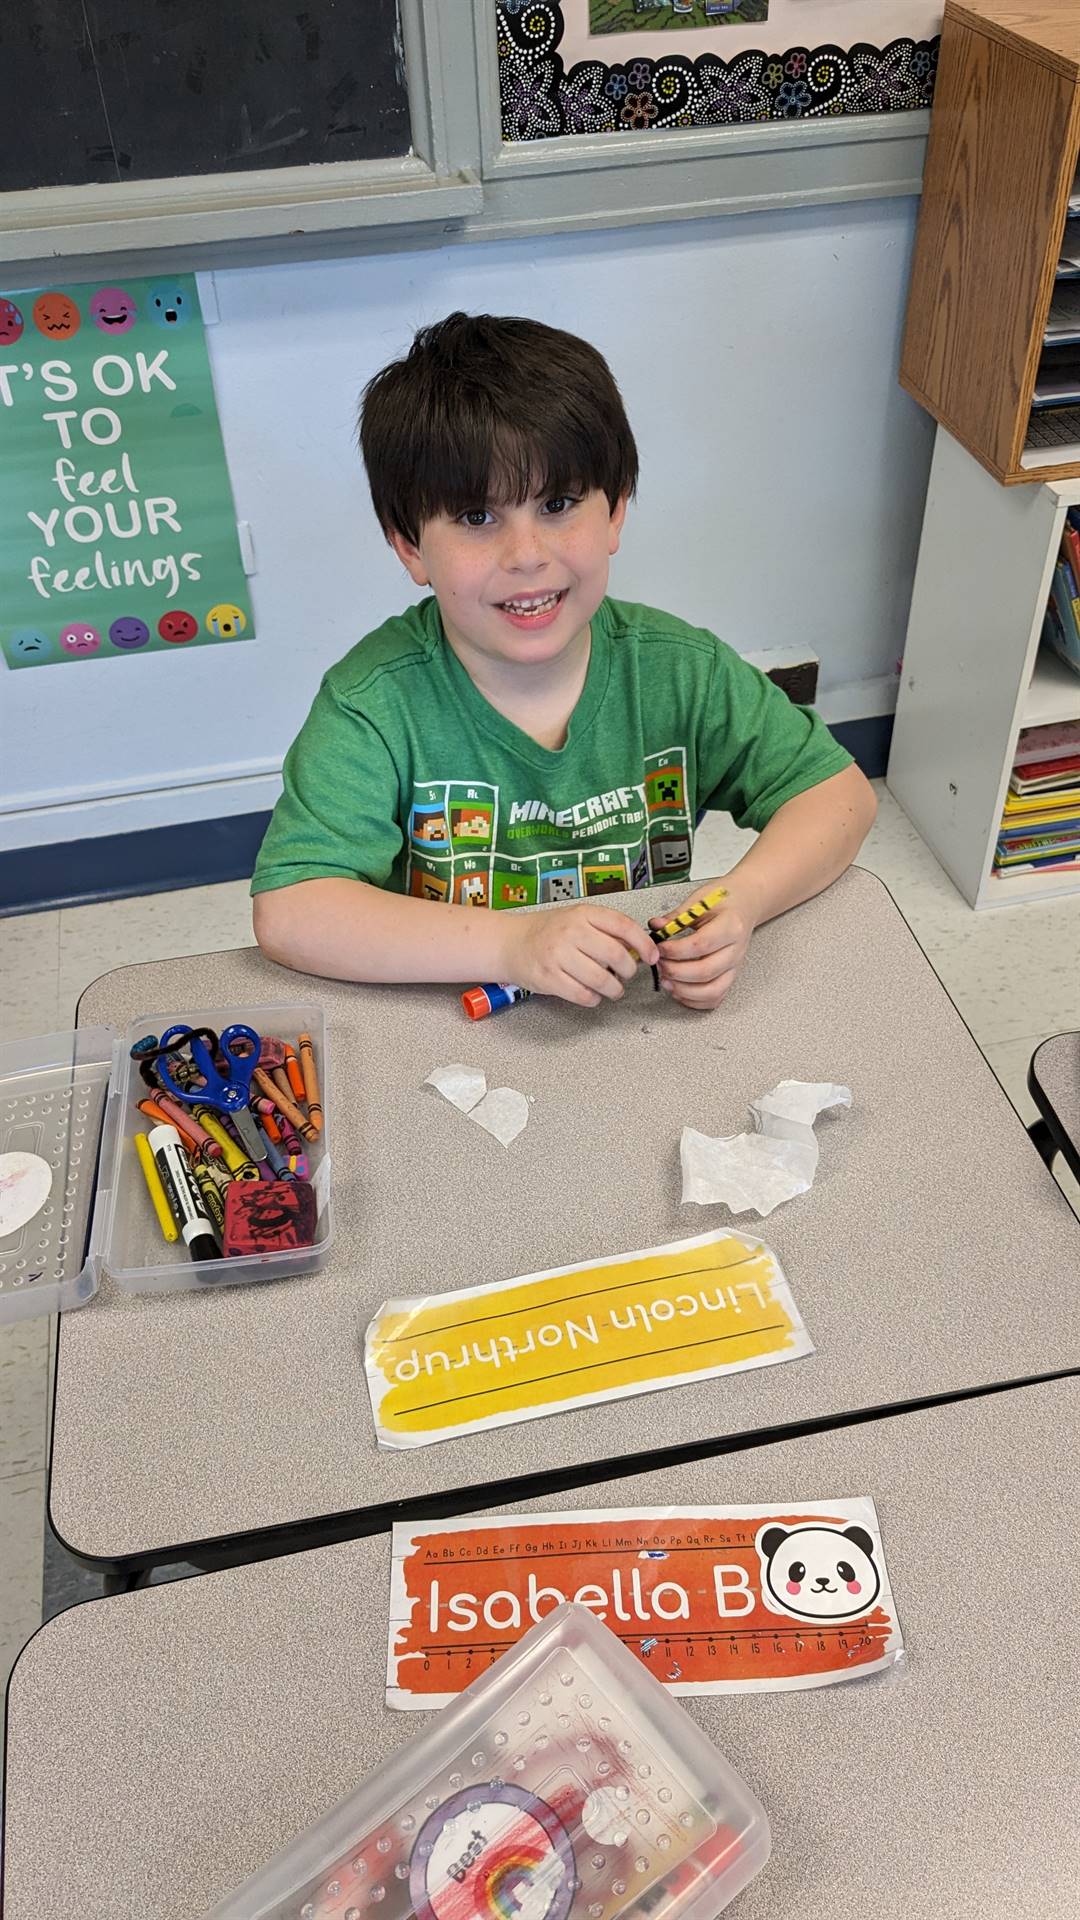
[496,0,940,140]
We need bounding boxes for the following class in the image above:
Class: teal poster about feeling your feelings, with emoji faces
[0,275,254,666]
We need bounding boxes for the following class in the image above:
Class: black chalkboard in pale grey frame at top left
[0,0,411,192]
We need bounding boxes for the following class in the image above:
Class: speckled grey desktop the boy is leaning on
[50,872,1080,1565]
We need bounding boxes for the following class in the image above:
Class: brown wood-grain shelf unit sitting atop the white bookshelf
[899,0,1080,486]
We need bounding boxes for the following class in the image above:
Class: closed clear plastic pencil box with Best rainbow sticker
[208,1603,771,1920]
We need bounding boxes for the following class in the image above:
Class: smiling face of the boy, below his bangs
[390,488,626,674]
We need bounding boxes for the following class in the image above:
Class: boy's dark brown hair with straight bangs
[359,313,638,545]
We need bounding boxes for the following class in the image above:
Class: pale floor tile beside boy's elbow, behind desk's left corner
[60,879,254,1021]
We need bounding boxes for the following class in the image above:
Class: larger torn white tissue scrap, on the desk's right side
[678,1081,851,1219]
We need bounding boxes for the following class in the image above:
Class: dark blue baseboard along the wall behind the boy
[0,714,892,914]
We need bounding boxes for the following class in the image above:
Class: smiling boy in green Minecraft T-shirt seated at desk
[252,313,874,1008]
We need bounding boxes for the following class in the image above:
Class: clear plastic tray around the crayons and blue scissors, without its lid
[90,1004,332,1294]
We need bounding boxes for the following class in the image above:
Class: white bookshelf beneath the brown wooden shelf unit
[888,426,1080,908]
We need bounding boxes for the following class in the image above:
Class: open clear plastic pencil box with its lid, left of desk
[0,1004,332,1325]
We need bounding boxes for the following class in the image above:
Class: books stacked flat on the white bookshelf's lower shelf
[994,720,1080,879]
